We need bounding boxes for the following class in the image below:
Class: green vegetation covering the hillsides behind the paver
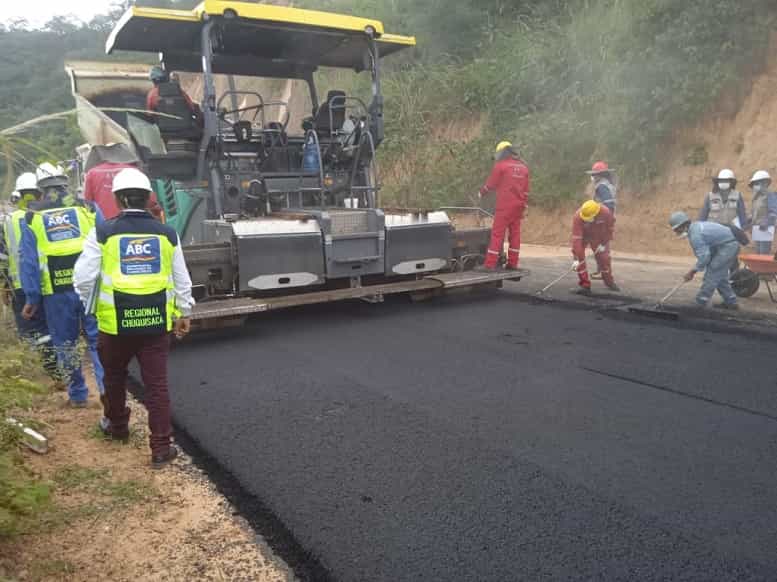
[0,0,777,206]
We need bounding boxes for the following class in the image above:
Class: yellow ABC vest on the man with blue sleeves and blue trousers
[27,206,95,295]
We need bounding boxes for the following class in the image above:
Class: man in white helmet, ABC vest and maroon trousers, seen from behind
[75,168,194,469]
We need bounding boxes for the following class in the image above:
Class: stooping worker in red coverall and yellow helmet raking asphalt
[572,200,620,295]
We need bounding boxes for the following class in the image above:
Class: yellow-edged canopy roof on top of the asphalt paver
[106,0,416,77]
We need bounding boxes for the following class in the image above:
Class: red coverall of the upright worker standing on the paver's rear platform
[480,157,531,269]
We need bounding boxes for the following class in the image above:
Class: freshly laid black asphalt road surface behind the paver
[171,292,777,582]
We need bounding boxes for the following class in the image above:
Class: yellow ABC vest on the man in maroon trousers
[97,233,178,335]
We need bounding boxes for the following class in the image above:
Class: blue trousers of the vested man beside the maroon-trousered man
[43,291,105,402]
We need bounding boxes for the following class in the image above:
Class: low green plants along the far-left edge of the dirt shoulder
[0,322,49,537]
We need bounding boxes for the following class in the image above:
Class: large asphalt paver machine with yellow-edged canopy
[68,0,525,322]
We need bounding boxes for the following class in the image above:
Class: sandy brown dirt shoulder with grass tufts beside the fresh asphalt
[0,393,294,582]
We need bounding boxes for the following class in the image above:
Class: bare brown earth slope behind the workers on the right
[525,37,777,254]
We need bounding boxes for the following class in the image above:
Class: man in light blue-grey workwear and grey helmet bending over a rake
[669,212,739,310]
